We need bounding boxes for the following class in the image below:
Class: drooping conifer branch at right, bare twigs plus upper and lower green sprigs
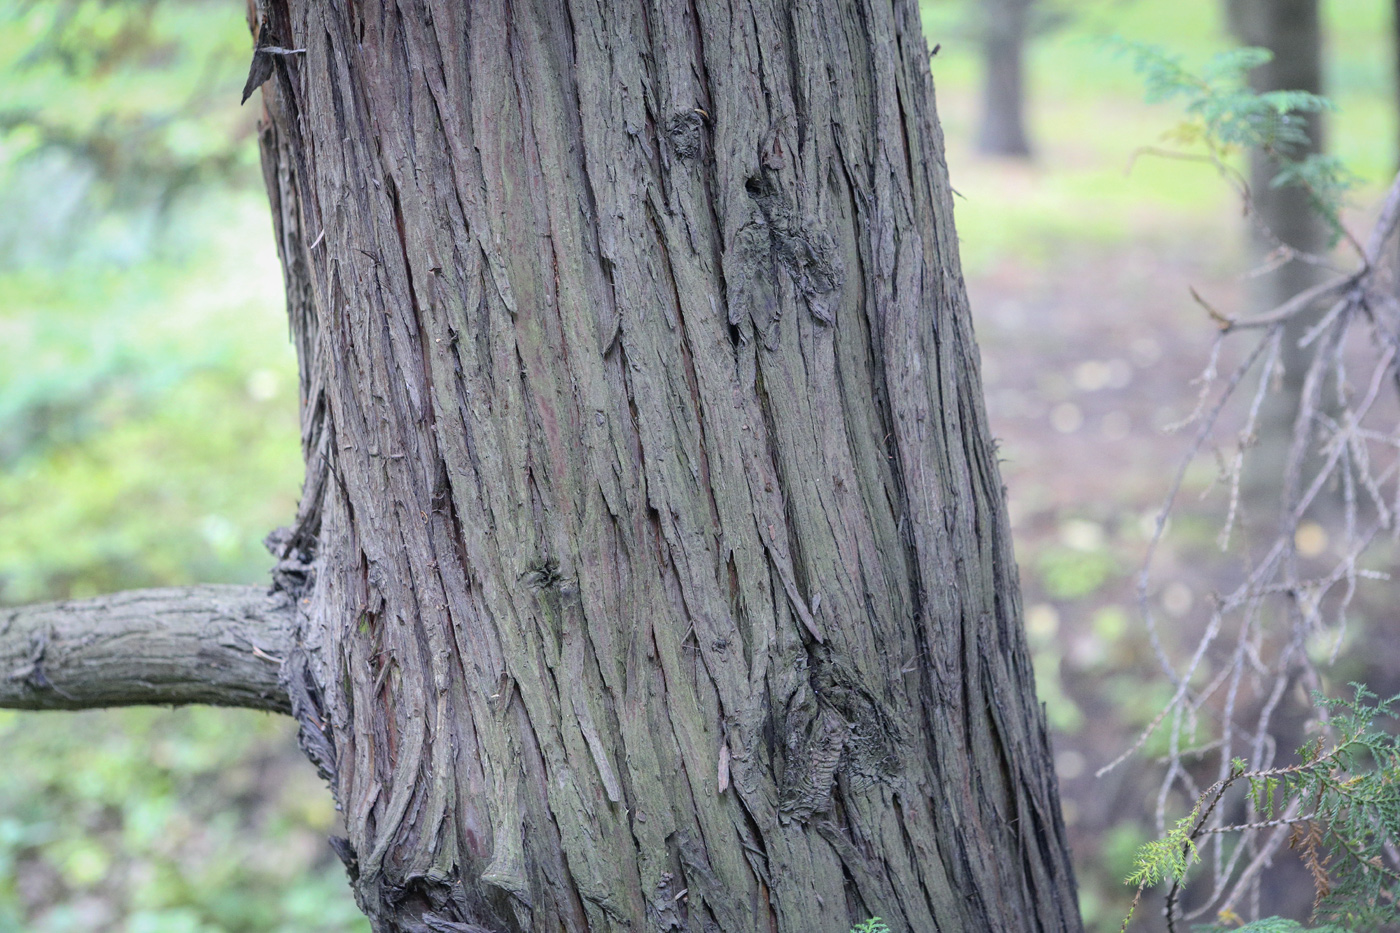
[1100,43,1400,932]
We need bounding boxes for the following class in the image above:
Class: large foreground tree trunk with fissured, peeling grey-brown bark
[259,0,1079,933]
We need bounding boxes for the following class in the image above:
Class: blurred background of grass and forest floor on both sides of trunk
[0,0,1400,933]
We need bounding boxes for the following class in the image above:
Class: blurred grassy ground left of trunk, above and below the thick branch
[0,197,368,933]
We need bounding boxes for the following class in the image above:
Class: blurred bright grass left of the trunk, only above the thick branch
[0,193,300,602]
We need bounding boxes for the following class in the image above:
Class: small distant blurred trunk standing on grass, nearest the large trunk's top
[977,0,1032,157]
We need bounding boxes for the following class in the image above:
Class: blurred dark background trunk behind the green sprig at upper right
[1228,0,1329,500]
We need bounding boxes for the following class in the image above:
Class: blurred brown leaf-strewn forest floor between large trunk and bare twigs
[955,182,1400,930]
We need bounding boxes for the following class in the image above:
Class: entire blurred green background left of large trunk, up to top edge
[0,0,368,933]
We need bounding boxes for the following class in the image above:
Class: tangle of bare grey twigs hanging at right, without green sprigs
[1120,168,1400,929]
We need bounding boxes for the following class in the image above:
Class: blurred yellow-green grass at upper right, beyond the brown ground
[923,0,1400,275]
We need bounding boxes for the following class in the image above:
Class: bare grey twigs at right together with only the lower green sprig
[1105,170,1400,930]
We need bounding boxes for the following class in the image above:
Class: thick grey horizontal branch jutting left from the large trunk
[0,586,293,713]
